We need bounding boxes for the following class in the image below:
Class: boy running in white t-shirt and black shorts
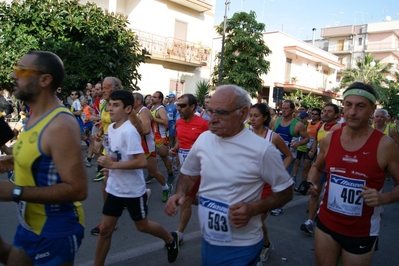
[94,90,179,266]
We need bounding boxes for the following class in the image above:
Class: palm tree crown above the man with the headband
[340,53,393,100]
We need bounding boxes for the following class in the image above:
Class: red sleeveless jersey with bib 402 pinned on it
[318,128,386,237]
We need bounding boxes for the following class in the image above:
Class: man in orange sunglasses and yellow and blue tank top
[0,51,87,265]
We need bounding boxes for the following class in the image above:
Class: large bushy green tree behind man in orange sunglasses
[0,0,148,91]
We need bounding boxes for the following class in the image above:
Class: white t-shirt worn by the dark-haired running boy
[105,120,146,198]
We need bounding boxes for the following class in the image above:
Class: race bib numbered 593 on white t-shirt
[198,196,232,243]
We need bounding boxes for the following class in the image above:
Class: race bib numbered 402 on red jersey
[327,174,366,216]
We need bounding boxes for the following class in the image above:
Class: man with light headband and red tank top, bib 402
[308,82,399,265]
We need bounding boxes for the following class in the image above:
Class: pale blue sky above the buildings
[215,0,399,40]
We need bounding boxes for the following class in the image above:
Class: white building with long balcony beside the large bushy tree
[81,0,215,96]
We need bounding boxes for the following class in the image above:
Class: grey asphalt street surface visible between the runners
[0,151,399,266]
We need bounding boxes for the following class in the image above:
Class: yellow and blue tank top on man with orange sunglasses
[13,106,84,237]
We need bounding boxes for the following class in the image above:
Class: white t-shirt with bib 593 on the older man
[180,128,293,246]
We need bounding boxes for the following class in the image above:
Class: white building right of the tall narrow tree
[212,31,343,107]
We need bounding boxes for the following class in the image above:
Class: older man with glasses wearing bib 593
[165,85,293,265]
